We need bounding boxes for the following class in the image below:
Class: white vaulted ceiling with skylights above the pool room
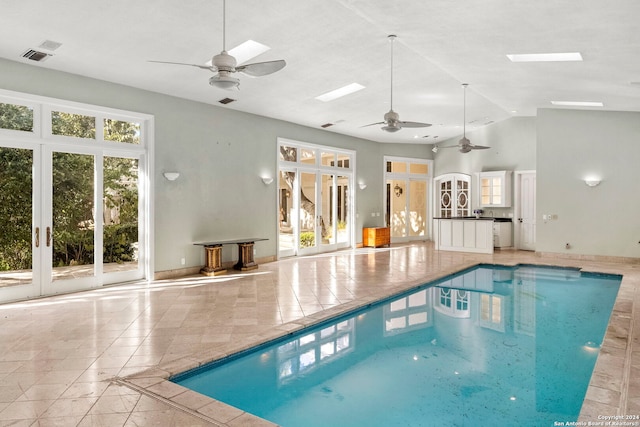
[0,0,640,143]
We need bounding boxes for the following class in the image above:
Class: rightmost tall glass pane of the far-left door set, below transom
[102,156,141,274]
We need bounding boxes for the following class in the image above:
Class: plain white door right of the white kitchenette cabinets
[514,172,536,251]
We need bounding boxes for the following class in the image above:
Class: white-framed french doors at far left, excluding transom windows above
[0,141,146,301]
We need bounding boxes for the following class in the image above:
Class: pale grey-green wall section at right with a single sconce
[536,109,640,258]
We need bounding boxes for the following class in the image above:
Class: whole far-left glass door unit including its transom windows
[0,92,149,301]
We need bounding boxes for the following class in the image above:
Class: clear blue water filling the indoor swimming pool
[173,265,621,427]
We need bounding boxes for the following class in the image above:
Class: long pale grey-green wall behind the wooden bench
[0,59,431,271]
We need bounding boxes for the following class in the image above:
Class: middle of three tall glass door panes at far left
[51,152,96,282]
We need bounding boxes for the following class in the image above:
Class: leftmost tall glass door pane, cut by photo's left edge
[0,147,34,289]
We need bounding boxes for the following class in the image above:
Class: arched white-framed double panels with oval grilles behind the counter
[435,173,471,218]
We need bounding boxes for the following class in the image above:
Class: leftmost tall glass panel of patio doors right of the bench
[278,170,298,257]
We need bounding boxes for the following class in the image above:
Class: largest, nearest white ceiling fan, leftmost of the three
[149,0,287,90]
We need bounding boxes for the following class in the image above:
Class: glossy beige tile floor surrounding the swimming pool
[0,243,640,427]
